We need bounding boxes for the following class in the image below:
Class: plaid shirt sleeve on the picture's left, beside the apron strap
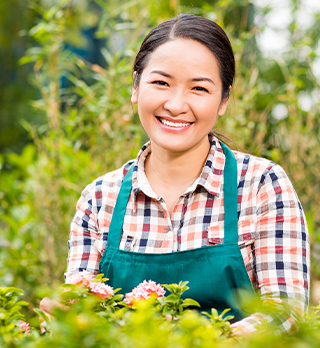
[65,183,101,283]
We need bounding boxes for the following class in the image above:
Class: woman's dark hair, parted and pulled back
[133,14,235,99]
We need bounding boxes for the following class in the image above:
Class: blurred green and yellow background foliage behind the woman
[0,0,320,316]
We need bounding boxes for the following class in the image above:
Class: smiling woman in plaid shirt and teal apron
[65,15,309,332]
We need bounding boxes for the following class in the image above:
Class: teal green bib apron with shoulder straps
[99,143,254,320]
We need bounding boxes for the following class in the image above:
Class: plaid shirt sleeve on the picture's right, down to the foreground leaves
[232,164,310,333]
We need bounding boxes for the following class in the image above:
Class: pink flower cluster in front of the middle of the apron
[124,280,166,307]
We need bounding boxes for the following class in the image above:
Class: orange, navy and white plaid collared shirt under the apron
[65,134,310,332]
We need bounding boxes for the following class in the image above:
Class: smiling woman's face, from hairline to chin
[131,38,228,153]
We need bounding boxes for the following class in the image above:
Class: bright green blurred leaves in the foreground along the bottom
[0,276,320,348]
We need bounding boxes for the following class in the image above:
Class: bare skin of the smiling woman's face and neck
[131,37,228,215]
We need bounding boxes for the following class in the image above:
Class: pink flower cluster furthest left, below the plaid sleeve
[68,271,114,300]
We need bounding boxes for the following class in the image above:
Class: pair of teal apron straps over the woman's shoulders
[107,142,238,250]
